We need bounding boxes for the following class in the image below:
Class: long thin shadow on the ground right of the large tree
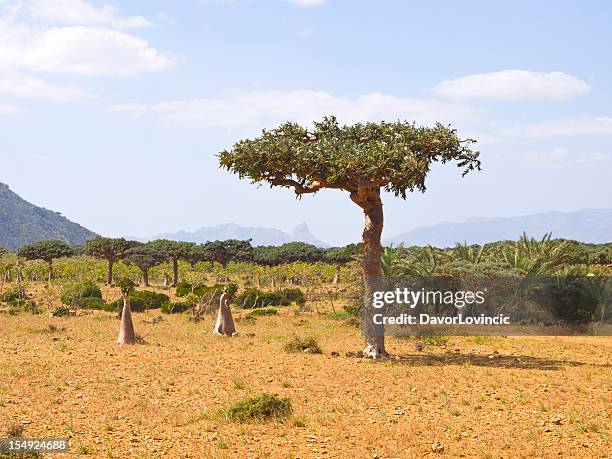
[376,353,612,370]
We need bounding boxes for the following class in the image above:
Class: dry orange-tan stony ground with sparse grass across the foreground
[0,302,612,458]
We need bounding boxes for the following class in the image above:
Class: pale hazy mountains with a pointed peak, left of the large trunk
[139,223,329,247]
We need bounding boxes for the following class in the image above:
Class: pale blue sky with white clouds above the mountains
[0,0,612,243]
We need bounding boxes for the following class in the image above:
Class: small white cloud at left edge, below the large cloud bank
[0,74,94,102]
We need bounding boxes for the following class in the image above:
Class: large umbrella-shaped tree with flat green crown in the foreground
[219,117,480,358]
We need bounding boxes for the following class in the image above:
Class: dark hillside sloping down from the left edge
[0,183,96,251]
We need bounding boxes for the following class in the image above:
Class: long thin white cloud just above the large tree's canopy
[111,90,478,129]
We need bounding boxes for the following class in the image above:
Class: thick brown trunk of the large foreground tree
[351,188,387,359]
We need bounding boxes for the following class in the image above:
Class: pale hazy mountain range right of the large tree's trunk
[383,209,612,247]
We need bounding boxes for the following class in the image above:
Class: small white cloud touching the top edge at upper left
[29,0,153,29]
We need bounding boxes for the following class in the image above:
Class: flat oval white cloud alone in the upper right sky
[430,70,590,100]
